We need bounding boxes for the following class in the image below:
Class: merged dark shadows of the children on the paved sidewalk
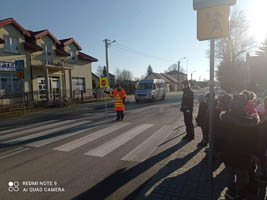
[138,152,226,200]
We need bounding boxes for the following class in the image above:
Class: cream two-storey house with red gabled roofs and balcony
[0,18,97,104]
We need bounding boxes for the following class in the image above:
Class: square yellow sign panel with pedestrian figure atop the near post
[197,5,230,40]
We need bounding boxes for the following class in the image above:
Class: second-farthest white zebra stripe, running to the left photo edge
[2,120,91,144]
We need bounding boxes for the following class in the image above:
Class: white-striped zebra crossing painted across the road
[0,120,180,162]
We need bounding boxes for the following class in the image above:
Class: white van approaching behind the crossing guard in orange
[135,79,166,103]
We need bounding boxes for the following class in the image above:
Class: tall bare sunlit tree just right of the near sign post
[215,10,255,91]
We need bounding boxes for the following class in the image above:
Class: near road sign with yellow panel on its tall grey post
[193,0,236,199]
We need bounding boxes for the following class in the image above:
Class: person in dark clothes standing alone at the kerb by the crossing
[180,80,195,140]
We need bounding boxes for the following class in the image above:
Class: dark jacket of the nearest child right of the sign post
[219,112,259,168]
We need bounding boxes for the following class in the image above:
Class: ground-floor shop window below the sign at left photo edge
[0,73,23,96]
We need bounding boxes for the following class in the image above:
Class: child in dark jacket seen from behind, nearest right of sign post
[219,95,259,199]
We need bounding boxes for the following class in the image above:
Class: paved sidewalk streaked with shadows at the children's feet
[138,127,230,200]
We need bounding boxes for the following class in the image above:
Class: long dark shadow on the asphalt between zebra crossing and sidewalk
[73,140,192,200]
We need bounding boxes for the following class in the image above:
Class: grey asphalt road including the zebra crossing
[0,91,205,200]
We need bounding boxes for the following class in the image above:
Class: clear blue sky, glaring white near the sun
[0,0,267,80]
